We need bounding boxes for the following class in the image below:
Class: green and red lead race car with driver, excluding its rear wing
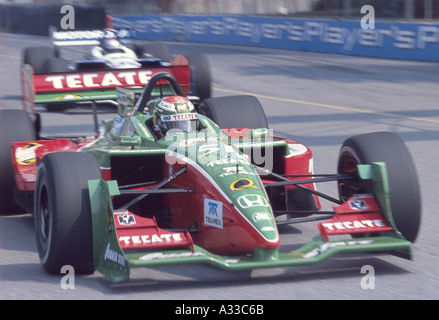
[0,73,421,281]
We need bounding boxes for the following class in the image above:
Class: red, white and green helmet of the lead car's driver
[153,96,198,135]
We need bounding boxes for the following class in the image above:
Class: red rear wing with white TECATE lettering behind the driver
[20,56,190,114]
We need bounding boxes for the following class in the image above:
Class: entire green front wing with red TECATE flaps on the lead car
[89,163,412,282]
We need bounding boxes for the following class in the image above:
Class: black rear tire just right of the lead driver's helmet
[198,95,268,129]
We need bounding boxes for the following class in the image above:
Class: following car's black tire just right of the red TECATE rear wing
[186,54,212,100]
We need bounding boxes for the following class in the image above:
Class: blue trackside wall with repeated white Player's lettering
[114,15,439,61]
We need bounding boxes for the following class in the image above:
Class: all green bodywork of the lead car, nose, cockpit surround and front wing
[85,101,412,282]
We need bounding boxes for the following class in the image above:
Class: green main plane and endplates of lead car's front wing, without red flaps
[89,163,412,282]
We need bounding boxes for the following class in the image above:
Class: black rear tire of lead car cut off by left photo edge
[0,109,36,214]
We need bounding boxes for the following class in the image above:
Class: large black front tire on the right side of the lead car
[338,132,421,242]
